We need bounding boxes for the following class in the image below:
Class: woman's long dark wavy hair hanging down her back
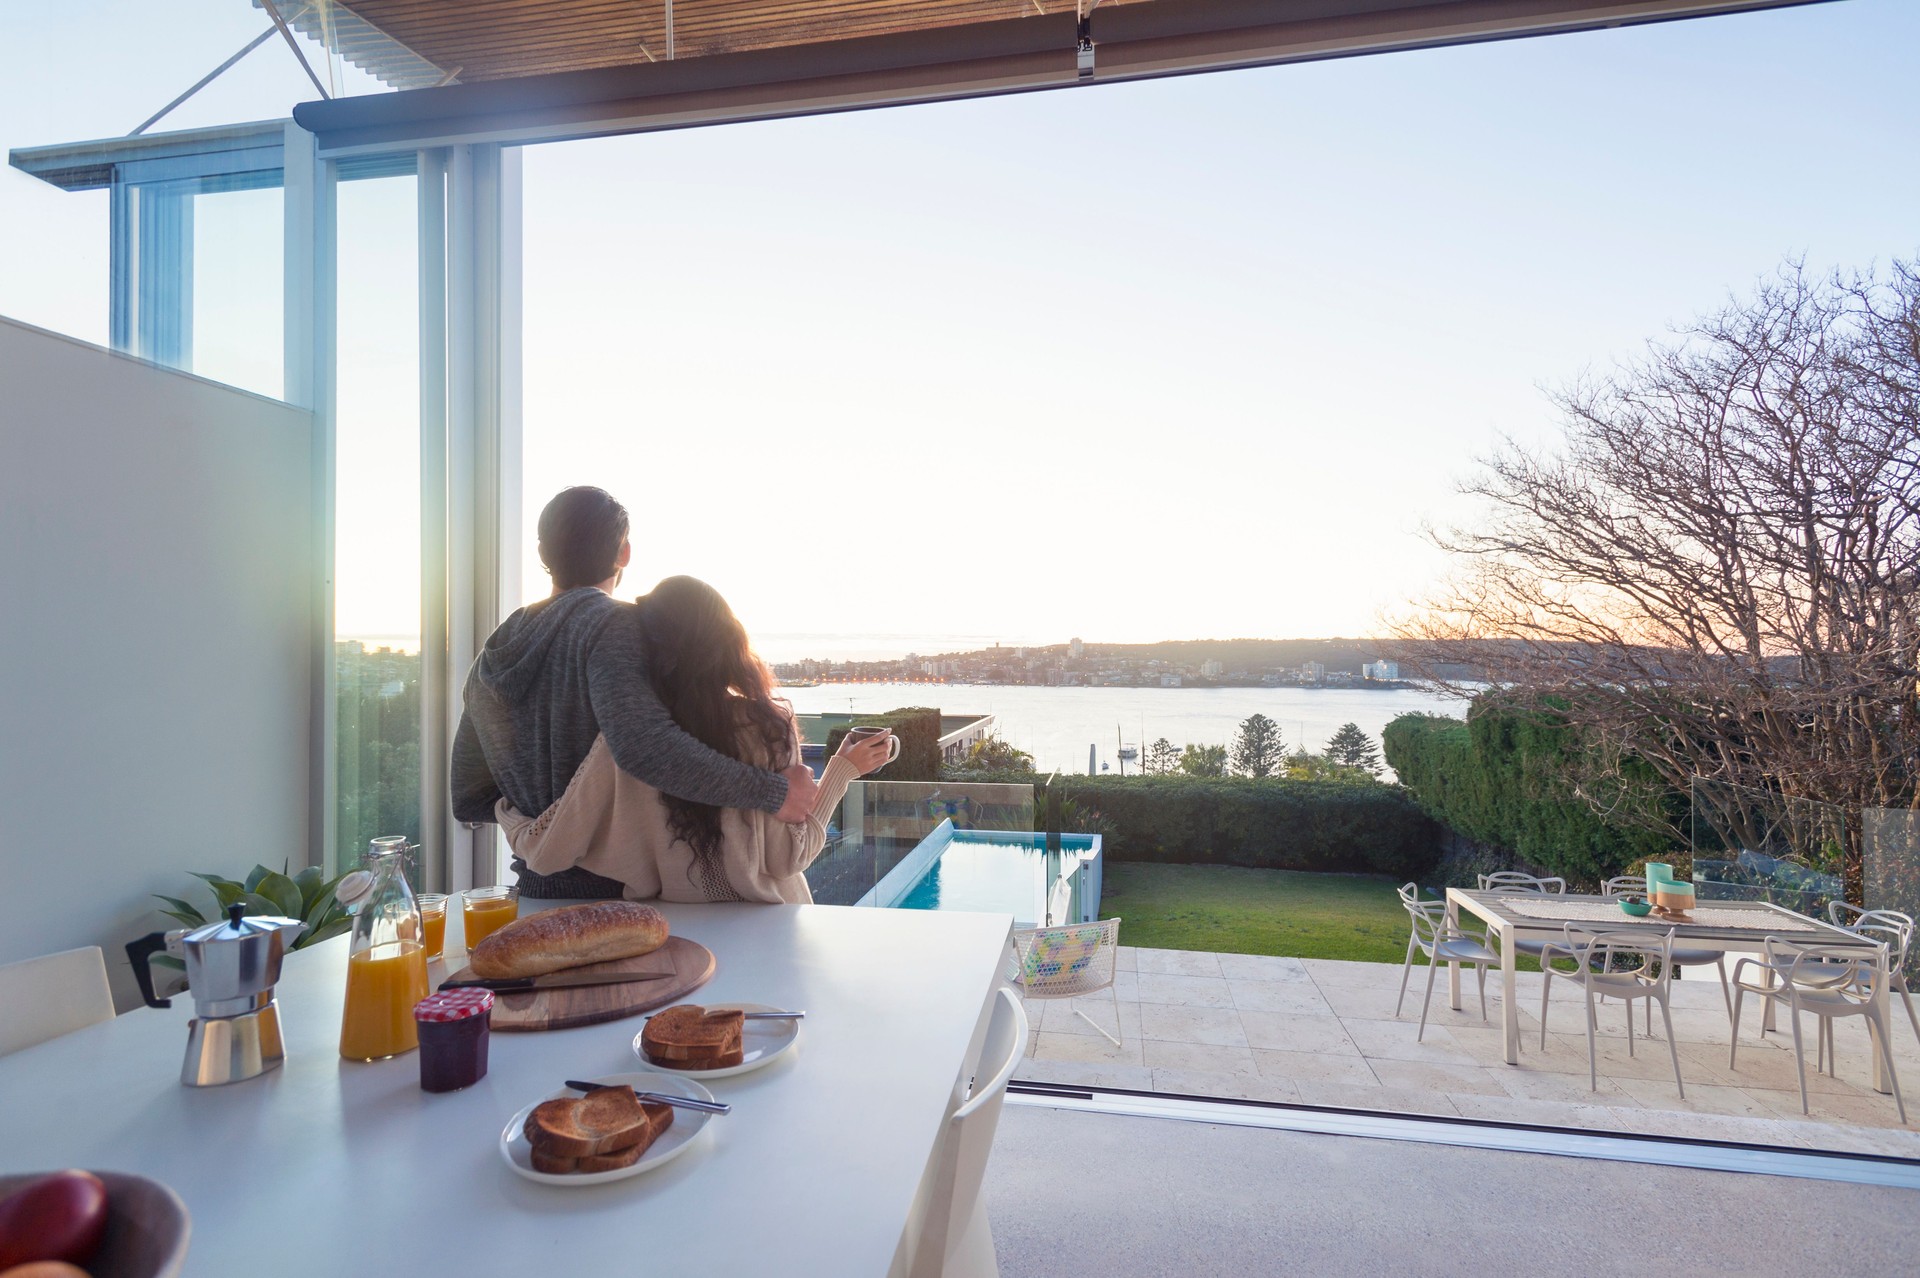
[636,578,795,900]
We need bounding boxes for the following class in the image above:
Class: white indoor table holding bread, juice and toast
[0,902,1012,1278]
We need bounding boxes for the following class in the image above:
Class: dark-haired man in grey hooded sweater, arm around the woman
[451,487,816,896]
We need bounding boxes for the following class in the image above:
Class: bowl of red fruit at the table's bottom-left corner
[0,1171,188,1278]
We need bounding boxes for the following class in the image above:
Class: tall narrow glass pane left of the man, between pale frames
[334,177,420,865]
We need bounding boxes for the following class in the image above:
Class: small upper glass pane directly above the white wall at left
[192,186,286,399]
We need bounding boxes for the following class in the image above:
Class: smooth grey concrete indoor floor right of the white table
[985,1103,1920,1278]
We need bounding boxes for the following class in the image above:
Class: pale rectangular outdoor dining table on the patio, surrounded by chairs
[1446,888,1893,1092]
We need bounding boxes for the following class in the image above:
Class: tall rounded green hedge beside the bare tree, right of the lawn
[1380,708,1674,885]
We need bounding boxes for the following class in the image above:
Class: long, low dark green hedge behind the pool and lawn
[960,773,1440,879]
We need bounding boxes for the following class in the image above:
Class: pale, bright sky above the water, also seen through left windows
[0,0,1920,656]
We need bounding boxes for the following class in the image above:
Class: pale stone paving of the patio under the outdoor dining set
[1014,946,1920,1157]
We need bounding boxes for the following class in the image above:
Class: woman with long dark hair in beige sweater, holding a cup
[495,578,891,904]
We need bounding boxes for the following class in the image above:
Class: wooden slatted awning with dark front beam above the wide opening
[291,0,1824,155]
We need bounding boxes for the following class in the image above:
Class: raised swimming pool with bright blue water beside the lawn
[860,821,1100,927]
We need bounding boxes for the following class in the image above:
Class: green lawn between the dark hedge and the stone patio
[1100,862,1540,971]
